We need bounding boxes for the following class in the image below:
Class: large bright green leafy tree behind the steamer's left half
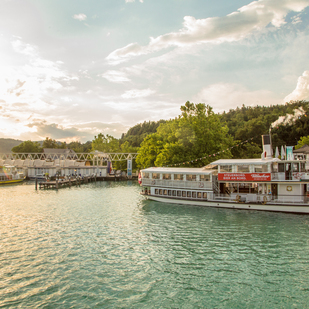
[136,101,233,167]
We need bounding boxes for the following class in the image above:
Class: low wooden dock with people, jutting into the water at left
[35,176,97,189]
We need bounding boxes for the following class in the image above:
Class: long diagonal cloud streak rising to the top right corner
[106,0,309,64]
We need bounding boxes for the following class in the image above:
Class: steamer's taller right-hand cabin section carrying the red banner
[206,158,309,202]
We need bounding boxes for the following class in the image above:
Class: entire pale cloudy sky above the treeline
[0,0,309,142]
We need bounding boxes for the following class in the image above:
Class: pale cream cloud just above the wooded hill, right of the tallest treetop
[193,83,280,112]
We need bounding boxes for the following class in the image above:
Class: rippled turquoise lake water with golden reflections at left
[0,182,309,308]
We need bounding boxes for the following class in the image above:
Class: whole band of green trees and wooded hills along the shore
[6,101,309,169]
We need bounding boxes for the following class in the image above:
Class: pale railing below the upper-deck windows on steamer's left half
[142,178,212,190]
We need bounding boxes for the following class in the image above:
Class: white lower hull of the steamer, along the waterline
[144,195,309,214]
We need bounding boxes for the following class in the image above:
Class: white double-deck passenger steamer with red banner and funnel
[140,135,309,214]
